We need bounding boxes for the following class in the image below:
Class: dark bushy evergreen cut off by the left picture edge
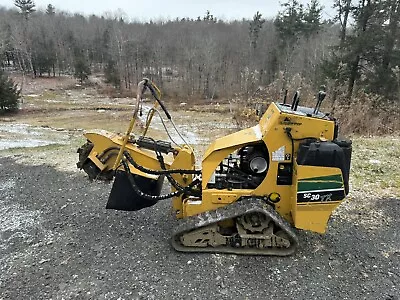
[0,69,21,113]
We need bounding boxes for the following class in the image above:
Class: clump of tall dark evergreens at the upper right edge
[325,0,400,100]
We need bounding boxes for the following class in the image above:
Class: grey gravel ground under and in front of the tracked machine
[0,158,400,300]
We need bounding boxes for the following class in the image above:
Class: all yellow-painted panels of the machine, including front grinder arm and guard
[85,103,350,233]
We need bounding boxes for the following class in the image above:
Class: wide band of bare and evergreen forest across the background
[0,0,400,134]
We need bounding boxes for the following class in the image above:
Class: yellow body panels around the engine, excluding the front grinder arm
[174,103,344,233]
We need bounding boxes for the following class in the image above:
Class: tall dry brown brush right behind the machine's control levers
[230,76,400,136]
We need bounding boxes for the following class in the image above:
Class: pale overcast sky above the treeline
[0,0,334,21]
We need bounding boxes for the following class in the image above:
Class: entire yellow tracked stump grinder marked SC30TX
[77,79,352,256]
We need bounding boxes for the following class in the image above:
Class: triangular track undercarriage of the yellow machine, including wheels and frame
[172,198,298,256]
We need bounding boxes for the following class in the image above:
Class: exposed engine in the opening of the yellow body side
[207,143,269,189]
